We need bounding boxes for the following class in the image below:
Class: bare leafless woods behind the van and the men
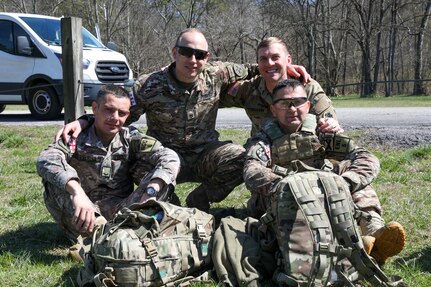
[0,0,431,97]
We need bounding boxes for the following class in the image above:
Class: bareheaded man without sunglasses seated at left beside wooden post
[37,86,180,241]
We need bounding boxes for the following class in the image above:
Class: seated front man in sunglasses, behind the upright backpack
[244,79,405,264]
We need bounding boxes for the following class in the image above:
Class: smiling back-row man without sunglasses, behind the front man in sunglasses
[221,37,342,135]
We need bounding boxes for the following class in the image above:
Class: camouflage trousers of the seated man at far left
[44,179,154,242]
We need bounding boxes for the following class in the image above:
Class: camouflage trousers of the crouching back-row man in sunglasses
[177,141,245,211]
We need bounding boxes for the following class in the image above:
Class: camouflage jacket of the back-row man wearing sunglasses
[127,62,258,151]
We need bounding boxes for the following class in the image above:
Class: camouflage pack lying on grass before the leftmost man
[77,200,214,287]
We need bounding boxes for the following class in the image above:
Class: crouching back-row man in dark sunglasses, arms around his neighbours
[56,29,308,211]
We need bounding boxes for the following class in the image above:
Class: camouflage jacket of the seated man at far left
[37,125,179,205]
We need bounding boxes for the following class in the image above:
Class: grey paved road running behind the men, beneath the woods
[0,107,431,130]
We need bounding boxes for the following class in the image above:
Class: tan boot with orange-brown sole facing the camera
[371,221,406,265]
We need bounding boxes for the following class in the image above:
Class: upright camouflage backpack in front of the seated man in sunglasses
[261,170,395,286]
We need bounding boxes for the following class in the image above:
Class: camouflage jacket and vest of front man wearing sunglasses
[244,114,380,194]
